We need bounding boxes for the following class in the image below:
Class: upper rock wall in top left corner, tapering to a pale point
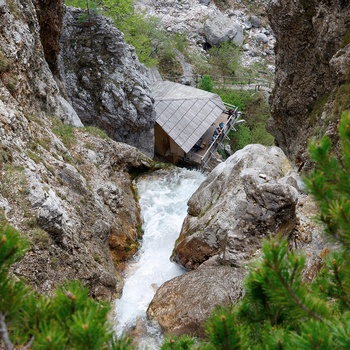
[0,1,82,126]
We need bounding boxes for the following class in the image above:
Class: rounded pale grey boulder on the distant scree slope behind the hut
[204,15,244,46]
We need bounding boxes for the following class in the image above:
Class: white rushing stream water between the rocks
[116,168,205,347]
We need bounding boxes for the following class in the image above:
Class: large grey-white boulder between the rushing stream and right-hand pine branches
[172,145,298,270]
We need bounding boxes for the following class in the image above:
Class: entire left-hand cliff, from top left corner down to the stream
[0,0,156,299]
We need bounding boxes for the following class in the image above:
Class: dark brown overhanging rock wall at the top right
[267,0,350,166]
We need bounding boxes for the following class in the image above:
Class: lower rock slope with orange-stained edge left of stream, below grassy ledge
[0,102,151,299]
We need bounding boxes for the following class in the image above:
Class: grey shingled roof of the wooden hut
[152,81,225,153]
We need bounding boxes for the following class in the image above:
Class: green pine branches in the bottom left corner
[0,221,132,350]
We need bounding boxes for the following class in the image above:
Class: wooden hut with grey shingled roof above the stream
[152,80,227,165]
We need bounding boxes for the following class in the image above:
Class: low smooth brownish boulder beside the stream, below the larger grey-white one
[147,266,245,337]
